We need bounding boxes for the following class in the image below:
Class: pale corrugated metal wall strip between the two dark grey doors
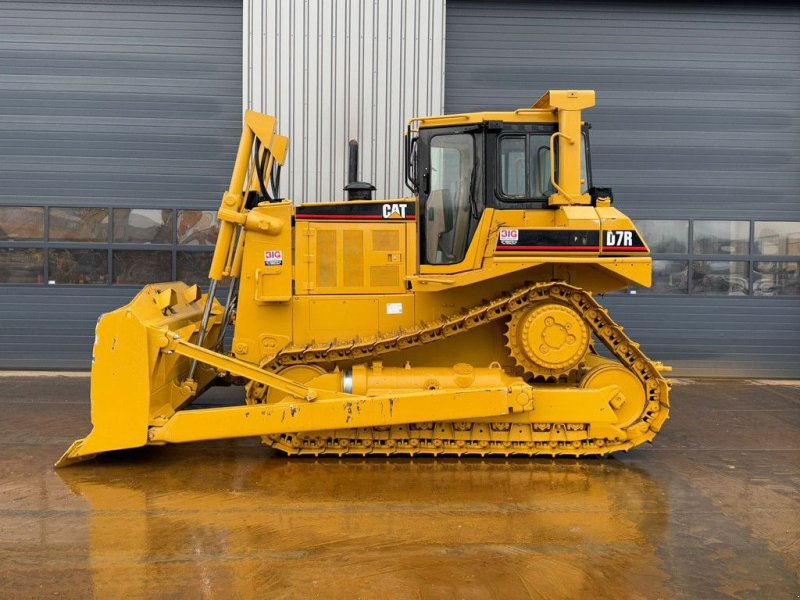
[244,0,444,203]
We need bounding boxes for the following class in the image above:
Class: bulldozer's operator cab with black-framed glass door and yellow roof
[406,91,593,265]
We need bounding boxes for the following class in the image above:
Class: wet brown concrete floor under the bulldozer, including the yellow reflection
[0,377,800,599]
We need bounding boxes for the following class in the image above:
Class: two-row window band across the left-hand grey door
[0,206,219,286]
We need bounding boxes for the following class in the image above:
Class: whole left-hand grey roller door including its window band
[0,0,242,369]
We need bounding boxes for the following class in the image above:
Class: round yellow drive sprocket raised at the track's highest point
[506,302,591,379]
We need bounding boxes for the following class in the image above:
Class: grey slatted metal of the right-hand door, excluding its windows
[445,0,800,377]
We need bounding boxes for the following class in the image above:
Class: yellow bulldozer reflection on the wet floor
[60,456,666,598]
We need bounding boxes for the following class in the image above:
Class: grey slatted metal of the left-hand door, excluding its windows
[0,0,242,369]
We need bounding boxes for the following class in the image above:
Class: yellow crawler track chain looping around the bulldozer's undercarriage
[248,282,670,456]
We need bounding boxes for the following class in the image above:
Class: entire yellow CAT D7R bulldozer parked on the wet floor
[57,91,670,466]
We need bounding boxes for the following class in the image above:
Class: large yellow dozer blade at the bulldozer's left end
[56,282,222,467]
